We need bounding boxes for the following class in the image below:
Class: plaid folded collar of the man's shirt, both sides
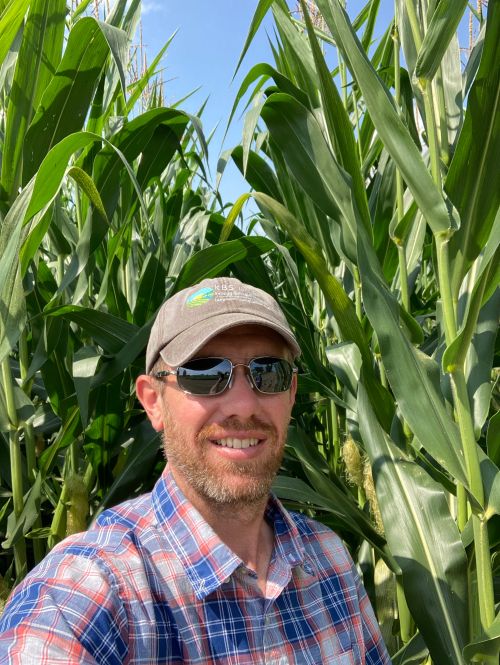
[152,465,304,600]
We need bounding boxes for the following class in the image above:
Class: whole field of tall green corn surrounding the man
[0,0,500,665]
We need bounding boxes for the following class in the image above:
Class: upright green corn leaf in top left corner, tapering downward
[1,0,66,200]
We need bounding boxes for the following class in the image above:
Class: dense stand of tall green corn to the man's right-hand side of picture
[222,0,500,665]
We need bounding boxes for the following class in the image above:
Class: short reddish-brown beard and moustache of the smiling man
[162,413,286,507]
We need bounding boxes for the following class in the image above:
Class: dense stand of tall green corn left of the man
[0,0,238,600]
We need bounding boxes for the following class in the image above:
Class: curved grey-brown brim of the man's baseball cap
[160,312,300,367]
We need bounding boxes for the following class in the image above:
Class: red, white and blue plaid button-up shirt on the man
[0,467,390,665]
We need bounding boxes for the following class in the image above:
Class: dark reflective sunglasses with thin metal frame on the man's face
[152,356,298,397]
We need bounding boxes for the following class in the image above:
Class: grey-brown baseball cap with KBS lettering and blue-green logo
[146,277,300,373]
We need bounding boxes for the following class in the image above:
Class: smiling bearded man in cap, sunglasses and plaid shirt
[0,277,390,665]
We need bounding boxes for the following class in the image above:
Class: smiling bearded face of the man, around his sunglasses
[148,326,296,506]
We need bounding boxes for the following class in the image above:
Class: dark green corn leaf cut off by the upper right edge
[445,2,500,296]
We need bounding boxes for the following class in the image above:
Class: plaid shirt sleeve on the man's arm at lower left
[0,552,128,665]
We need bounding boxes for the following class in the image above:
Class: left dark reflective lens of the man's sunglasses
[177,358,231,395]
